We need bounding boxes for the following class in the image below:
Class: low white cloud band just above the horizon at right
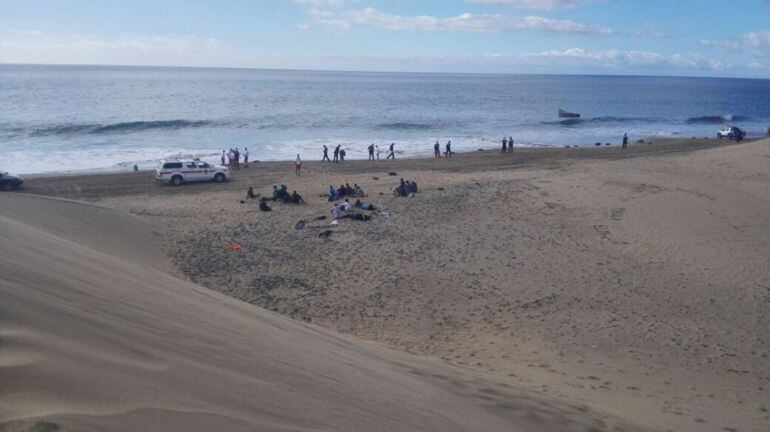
[522,48,732,71]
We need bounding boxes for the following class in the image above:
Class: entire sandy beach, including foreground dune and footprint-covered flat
[0,140,770,431]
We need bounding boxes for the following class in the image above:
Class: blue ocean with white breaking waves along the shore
[0,65,770,174]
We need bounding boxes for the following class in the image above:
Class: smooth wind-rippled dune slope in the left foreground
[0,194,636,431]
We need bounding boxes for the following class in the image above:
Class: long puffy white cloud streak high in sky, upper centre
[311,8,614,35]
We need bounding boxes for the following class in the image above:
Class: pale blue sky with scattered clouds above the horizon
[0,0,770,78]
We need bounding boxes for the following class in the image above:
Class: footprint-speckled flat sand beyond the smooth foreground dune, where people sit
[49,140,770,431]
